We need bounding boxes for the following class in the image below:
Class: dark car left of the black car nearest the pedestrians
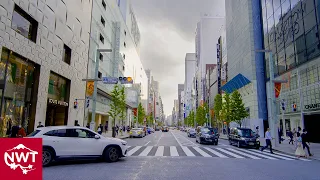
[196,127,218,145]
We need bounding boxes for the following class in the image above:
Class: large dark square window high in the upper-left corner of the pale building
[11,5,38,42]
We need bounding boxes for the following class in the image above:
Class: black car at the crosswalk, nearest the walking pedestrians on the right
[228,128,260,149]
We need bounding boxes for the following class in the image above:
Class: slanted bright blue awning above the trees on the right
[221,74,251,94]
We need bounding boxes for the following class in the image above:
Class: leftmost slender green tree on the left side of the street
[108,85,121,127]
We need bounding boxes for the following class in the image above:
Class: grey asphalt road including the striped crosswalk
[43,131,320,180]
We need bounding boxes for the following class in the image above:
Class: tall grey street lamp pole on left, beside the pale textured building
[90,49,112,130]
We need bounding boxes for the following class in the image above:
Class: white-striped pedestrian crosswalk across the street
[127,146,310,161]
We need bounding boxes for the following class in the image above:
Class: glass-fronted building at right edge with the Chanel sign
[261,0,320,142]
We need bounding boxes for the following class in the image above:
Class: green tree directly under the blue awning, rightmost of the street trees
[230,91,249,127]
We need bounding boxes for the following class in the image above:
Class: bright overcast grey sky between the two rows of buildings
[131,0,224,115]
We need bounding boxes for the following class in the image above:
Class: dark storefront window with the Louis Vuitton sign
[45,72,70,126]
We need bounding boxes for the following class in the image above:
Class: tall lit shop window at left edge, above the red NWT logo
[0,48,40,137]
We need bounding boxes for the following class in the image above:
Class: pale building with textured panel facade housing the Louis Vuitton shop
[0,0,91,134]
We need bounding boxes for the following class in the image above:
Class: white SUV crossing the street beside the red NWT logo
[28,126,128,166]
